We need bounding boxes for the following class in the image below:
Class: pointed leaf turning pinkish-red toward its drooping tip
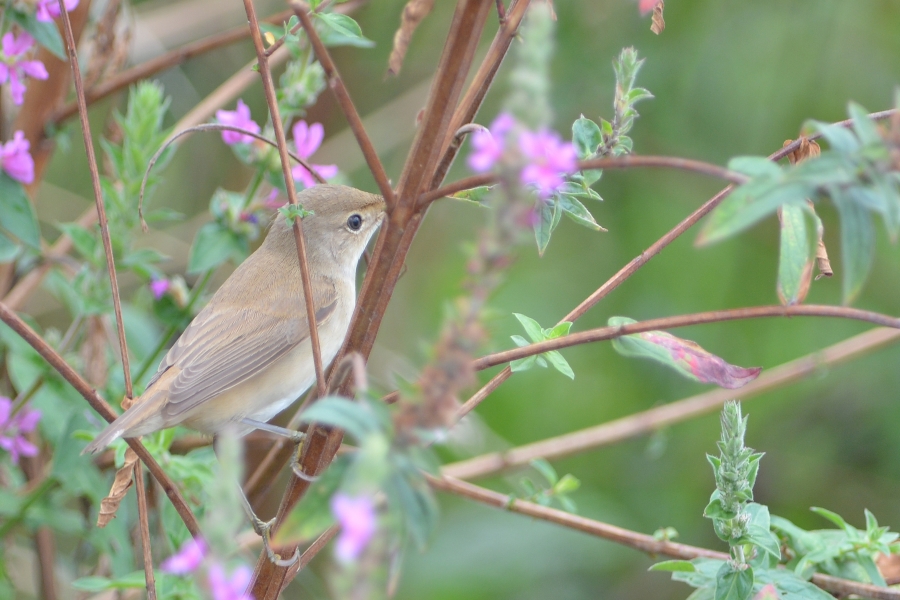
[609,317,762,389]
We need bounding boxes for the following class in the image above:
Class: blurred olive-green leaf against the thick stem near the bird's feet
[272,458,350,545]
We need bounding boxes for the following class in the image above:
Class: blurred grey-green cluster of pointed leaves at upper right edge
[698,103,900,303]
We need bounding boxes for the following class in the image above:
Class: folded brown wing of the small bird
[148,295,337,421]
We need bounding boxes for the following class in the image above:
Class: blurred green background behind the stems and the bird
[30,0,900,599]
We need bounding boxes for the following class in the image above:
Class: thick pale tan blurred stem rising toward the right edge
[450,327,900,479]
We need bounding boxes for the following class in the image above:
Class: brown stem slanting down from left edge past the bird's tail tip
[0,302,200,537]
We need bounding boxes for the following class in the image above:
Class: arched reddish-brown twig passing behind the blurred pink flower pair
[419,154,750,206]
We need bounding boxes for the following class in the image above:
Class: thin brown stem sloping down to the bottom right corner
[426,475,900,600]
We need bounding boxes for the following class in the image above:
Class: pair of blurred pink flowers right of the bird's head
[468,113,577,199]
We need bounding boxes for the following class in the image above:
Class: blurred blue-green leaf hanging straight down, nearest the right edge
[832,194,875,304]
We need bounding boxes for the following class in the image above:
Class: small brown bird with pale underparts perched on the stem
[84,185,385,454]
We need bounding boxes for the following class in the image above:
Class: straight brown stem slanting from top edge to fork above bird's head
[291,1,394,205]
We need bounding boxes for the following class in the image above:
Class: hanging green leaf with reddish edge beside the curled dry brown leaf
[777,204,815,306]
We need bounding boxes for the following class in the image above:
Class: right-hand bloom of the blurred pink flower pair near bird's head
[519,129,577,198]
